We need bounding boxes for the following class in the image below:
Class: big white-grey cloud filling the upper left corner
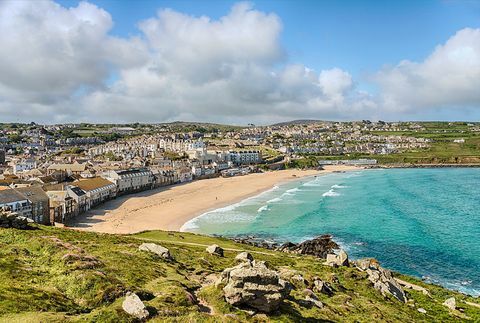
[0,1,146,121]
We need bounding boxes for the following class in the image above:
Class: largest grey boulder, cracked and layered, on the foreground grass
[217,261,289,313]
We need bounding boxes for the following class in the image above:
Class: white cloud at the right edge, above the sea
[375,28,480,112]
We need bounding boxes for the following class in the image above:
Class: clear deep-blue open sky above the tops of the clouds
[58,0,480,85]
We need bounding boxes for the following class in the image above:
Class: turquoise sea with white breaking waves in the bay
[183,168,480,295]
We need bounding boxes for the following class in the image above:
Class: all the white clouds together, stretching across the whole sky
[0,1,480,124]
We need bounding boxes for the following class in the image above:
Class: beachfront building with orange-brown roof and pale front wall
[72,177,117,209]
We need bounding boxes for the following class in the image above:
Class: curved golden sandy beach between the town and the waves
[70,166,358,234]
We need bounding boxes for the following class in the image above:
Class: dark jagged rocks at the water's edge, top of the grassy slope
[278,235,339,259]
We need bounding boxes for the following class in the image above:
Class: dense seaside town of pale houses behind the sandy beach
[0,120,479,225]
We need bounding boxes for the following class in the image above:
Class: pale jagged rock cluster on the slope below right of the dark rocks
[355,259,407,303]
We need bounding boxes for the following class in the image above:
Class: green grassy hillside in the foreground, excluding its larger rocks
[0,226,480,322]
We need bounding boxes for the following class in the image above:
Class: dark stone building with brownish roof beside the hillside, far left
[15,186,50,224]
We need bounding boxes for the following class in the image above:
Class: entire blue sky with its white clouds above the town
[0,0,480,124]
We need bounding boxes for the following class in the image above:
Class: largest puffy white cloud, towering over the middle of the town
[79,3,368,123]
